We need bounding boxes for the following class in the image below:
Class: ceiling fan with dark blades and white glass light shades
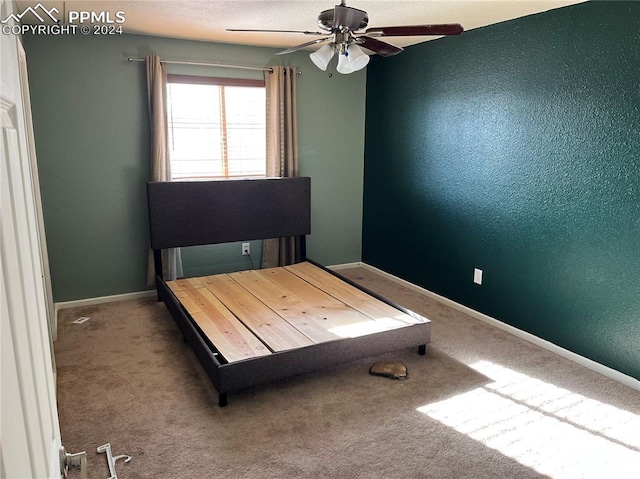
[227,0,463,74]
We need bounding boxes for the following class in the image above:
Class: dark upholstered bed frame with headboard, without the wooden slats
[147,177,431,406]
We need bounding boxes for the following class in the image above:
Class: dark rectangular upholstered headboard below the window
[147,177,311,250]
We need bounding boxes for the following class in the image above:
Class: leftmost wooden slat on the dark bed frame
[174,288,271,363]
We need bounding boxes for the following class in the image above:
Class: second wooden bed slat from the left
[204,274,313,351]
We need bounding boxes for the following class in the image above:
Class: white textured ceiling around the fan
[17,0,584,52]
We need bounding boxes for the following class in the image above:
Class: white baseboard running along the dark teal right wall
[360,263,640,391]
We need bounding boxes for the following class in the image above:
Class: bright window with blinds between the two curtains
[167,75,266,180]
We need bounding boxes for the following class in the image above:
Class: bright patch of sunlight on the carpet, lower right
[418,361,640,479]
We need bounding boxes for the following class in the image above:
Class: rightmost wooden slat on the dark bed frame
[285,262,425,329]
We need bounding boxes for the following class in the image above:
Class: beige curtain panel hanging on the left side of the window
[145,55,183,285]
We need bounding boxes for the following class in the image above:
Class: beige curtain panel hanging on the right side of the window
[262,66,304,268]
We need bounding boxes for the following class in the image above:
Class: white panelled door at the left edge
[0,0,61,479]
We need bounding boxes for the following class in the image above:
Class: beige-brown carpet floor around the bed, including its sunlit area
[55,268,640,479]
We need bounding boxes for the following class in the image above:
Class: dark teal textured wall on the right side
[363,2,640,379]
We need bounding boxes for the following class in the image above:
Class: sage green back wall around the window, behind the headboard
[24,34,366,302]
